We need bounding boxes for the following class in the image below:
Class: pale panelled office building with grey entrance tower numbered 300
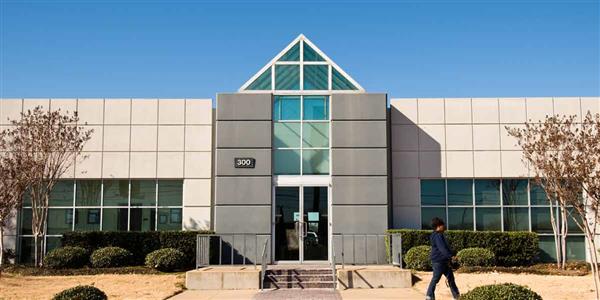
[0,35,600,262]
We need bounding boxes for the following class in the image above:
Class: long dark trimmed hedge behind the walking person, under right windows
[387,229,539,266]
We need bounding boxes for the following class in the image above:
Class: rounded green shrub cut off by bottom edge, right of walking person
[460,283,542,300]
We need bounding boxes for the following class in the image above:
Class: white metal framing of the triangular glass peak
[238,34,365,95]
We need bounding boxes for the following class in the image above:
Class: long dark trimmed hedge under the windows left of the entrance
[61,231,213,268]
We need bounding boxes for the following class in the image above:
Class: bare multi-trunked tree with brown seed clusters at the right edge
[507,112,600,299]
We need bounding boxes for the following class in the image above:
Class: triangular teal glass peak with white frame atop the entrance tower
[239,34,364,92]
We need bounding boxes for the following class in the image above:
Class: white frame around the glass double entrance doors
[271,175,333,264]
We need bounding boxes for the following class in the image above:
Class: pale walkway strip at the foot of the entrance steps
[169,288,425,300]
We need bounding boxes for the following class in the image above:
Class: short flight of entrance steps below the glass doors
[264,266,335,289]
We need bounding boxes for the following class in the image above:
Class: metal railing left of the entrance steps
[196,233,271,268]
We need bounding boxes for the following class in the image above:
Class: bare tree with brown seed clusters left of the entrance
[7,106,92,266]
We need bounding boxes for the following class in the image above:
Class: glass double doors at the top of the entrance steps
[274,186,329,263]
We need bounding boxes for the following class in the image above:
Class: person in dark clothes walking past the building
[425,217,460,300]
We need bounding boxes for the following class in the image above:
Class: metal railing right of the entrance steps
[332,233,402,268]
